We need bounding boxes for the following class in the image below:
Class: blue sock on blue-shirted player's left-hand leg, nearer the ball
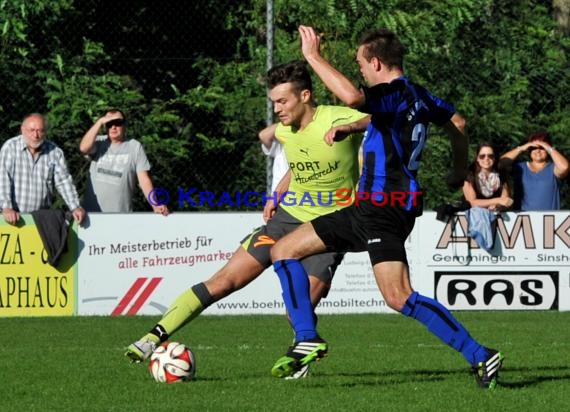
[273,259,317,342]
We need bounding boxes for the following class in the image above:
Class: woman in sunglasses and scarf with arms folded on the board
[463,143,513,211]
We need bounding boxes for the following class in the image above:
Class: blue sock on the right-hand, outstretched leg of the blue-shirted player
[402,292,488,365]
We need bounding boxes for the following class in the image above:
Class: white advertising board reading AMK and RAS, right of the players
[418,212,570,310]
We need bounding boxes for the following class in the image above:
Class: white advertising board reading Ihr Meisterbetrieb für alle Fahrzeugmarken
[78,212,390,315]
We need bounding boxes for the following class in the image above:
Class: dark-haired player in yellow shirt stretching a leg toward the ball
[126,61,369,378]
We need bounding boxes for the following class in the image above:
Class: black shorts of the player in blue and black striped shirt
[311,202,416,265]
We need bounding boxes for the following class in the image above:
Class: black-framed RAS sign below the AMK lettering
[434,272,558,310]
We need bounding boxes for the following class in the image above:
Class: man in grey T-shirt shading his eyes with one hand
[79,109,169,216]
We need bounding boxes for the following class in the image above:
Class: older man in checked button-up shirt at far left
[0,113,86,225]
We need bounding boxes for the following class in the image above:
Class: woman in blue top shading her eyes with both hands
[501,132,569,211]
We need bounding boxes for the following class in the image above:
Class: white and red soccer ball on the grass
[149,342,196,383]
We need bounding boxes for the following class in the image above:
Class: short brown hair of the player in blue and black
[360,29,406,69]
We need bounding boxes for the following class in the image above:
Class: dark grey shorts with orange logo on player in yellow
[241,209,344,285]
